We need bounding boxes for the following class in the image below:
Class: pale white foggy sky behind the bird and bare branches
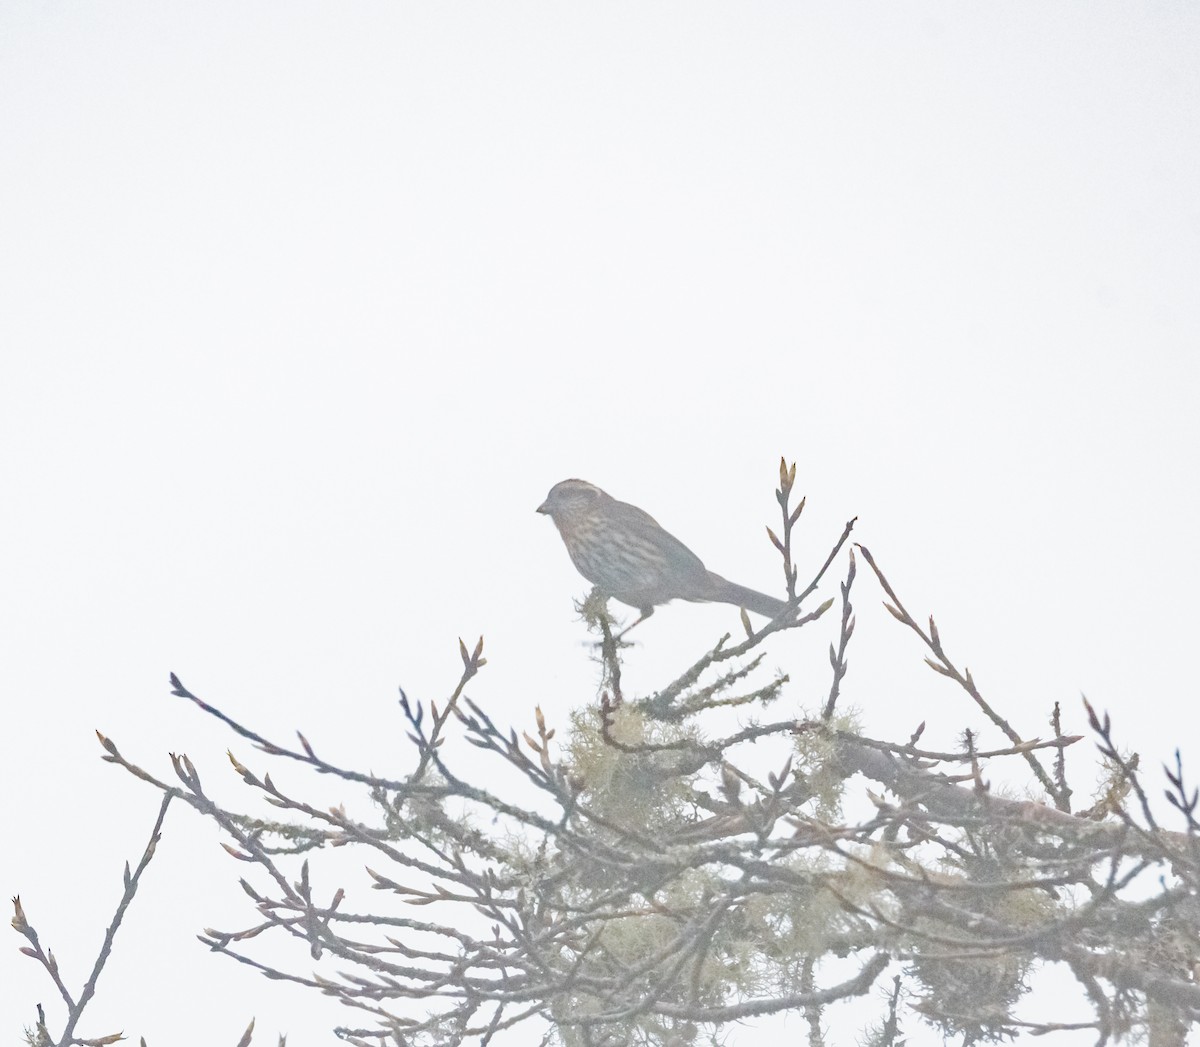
[0,0,1200,1047]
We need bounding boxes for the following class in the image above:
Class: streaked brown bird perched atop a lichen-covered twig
[538,480,787,628]
